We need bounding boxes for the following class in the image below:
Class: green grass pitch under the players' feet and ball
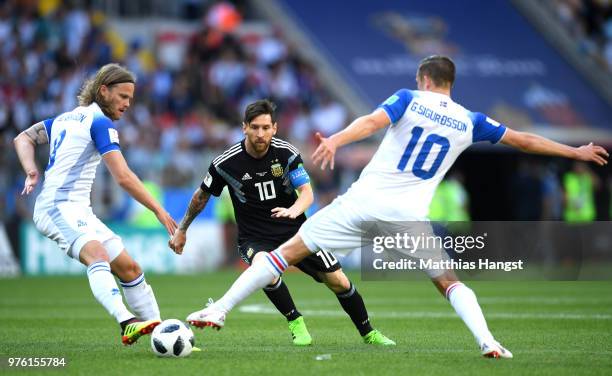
[0,271,612,376]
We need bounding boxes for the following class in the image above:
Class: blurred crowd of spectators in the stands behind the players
[0,0,612,228]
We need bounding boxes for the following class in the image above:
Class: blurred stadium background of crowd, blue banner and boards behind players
[0,0,612,276]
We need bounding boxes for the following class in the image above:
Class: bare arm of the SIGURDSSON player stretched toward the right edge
[501,128,609,166]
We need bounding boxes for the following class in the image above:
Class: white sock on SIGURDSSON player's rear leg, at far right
[446,282,493,346]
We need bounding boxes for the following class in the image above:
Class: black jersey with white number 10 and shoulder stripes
[201,138,306,243]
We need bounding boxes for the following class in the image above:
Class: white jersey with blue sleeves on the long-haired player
[36,102,119,209]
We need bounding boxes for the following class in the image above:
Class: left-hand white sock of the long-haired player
[87,261,134,323]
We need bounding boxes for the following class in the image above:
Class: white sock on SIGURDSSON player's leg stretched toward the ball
[215,250,287,312]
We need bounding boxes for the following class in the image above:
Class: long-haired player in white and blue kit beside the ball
[14,64,176,345]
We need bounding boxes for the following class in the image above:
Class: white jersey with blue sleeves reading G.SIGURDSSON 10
[343,89,506,221]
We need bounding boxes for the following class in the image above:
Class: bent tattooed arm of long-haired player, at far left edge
[13,122,49,195]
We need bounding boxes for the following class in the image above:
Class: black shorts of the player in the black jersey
[238,241,342,282]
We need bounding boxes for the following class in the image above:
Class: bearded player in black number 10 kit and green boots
[169,100,395,346]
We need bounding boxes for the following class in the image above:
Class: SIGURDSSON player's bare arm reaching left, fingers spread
[312,109,391,170]
